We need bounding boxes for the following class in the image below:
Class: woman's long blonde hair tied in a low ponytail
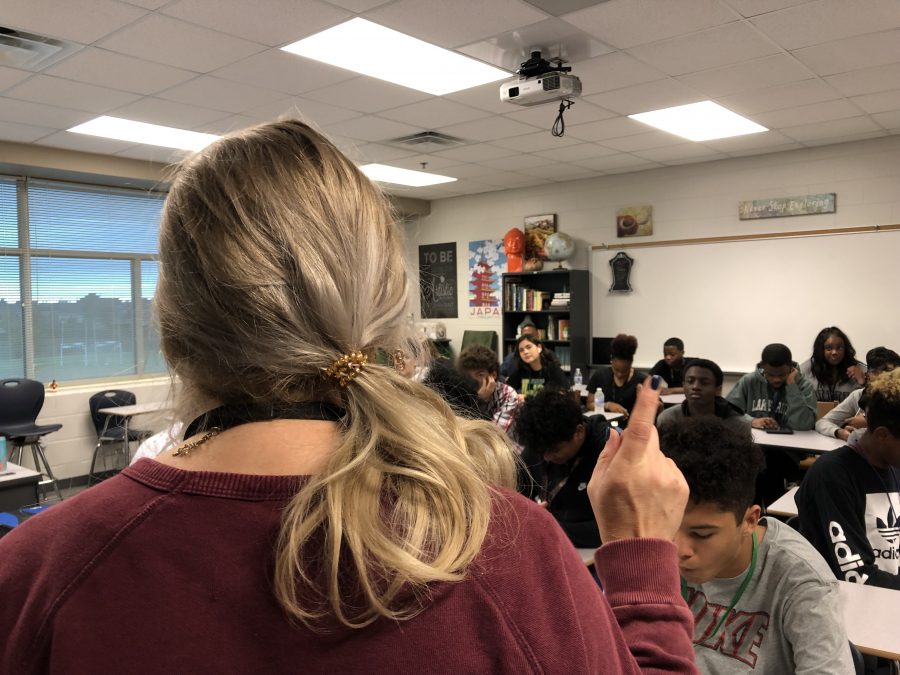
[156,121,514,627]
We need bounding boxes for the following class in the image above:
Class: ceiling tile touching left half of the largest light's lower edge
[210,49,359,94]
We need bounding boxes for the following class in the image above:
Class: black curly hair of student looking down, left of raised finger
[514,387,584,452]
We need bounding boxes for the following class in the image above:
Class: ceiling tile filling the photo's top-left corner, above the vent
[0,0,146,44]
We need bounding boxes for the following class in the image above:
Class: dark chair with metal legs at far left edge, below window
[0,378,62,500]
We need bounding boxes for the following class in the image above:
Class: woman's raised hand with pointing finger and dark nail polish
[588,375,688,543]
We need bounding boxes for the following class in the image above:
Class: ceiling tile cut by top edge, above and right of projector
[563,0,737,49]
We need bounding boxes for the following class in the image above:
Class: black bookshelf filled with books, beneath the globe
[502,270,591,378]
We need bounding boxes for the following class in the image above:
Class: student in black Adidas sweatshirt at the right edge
[797,369,900,589]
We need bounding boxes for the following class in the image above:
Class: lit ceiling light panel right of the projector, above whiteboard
[629,101,768,141]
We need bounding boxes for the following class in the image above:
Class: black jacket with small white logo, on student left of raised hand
[519,415,609,548]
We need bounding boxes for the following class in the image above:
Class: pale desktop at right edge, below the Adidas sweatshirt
[838,581,900,659]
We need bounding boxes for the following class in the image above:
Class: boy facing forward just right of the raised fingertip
[656,359,750,436]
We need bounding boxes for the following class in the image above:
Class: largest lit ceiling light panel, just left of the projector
[282,17,510,96]
